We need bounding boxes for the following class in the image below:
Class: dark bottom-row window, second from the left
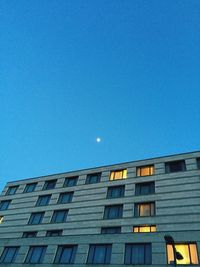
[25,246,47,263]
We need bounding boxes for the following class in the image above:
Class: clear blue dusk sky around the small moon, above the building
[0,0,200,192]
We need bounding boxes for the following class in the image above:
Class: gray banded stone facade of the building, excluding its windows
[0,151,200,267]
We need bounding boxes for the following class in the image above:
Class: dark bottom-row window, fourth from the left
[87,244,112,264]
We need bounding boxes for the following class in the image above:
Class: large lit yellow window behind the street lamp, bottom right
[167,243,199,264]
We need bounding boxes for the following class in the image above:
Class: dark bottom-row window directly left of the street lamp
[124,243,152,265]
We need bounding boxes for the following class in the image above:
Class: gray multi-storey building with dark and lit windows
[0,151,200,267]
